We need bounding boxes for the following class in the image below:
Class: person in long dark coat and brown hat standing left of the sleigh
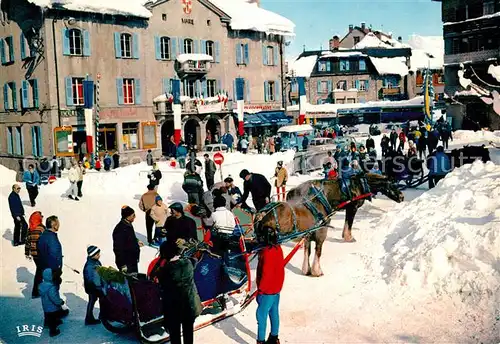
[113,205,144,273]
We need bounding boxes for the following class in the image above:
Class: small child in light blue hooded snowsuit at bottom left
[38,269,69,337]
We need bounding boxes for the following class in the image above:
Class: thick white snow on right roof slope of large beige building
[210,0,295,36]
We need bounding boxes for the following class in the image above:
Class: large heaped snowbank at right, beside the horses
[381,161,500,300]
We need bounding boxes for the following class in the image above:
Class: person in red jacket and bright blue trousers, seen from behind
[257,228,285,344]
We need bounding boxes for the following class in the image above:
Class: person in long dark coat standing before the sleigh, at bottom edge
[158,240,202,344]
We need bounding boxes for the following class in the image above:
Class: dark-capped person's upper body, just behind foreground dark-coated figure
[164,202,198,242]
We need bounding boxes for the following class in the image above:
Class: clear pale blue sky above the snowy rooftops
[261,0,443,57]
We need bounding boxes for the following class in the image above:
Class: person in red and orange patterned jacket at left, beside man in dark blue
[24,211,45,299]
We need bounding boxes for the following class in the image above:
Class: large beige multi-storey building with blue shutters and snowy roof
[0,0,294,168]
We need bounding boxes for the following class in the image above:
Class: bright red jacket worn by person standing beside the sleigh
[257,245,285,295]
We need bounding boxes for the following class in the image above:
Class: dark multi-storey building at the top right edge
[435,0,500,129]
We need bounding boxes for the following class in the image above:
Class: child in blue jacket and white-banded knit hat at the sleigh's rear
[83,245,104,325]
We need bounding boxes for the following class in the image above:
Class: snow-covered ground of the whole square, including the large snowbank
[0,134,500,344]
